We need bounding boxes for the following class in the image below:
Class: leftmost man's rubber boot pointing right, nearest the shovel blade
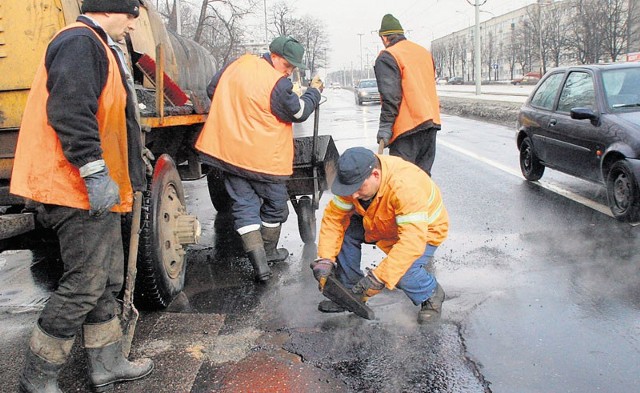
[83,318,153,392]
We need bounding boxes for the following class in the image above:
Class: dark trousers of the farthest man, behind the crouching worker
[389,128,438,176]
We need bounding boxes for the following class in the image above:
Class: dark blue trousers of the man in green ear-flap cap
[224,173,289,231]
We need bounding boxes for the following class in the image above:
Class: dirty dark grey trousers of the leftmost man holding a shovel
[38,205,124,338]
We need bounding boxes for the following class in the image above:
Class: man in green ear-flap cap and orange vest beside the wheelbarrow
[195,36,324,281]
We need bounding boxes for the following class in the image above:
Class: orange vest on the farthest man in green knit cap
[386,40,440,143]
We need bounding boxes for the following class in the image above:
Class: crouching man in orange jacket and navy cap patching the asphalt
[311,147,449,322]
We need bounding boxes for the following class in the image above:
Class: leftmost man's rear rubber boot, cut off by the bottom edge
[19,325,74,393]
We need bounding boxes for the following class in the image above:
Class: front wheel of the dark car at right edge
[607,160,640,222]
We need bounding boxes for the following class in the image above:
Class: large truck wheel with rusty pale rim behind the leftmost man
[134,154,192,310]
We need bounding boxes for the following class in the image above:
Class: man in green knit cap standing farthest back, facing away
[374,14,440,176]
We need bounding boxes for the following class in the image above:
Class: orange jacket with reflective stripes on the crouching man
[318,155,449,289]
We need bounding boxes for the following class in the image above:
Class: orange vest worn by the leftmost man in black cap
[10,22,133,212]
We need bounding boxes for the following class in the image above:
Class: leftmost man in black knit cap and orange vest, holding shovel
[10,0,153,392]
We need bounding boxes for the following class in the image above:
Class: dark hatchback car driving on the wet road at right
[516,63,640,222]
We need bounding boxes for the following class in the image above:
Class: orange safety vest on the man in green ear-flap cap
[195,54,293,176]
